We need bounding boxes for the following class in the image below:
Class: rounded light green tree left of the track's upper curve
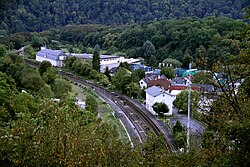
[52,78,71,98]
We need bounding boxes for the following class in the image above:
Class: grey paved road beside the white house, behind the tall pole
[170,107,205,134]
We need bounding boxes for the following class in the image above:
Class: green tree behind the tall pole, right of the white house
[173,90,200,114]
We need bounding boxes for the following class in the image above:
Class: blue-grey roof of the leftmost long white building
[36,49,66,60]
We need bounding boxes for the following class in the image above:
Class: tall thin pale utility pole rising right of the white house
[187,63,192,153]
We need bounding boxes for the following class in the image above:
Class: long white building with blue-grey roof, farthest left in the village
[36,47,67,67]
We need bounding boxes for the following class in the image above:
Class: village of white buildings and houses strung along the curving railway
[33,47,240,133]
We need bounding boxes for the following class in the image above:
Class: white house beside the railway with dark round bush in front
[145,86,172,115]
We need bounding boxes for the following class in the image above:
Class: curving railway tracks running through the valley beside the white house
[25,60,176,152]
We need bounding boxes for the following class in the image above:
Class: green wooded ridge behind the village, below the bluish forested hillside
[0,16,244,67]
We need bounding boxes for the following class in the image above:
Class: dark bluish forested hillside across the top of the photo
[0,0,249,35]
